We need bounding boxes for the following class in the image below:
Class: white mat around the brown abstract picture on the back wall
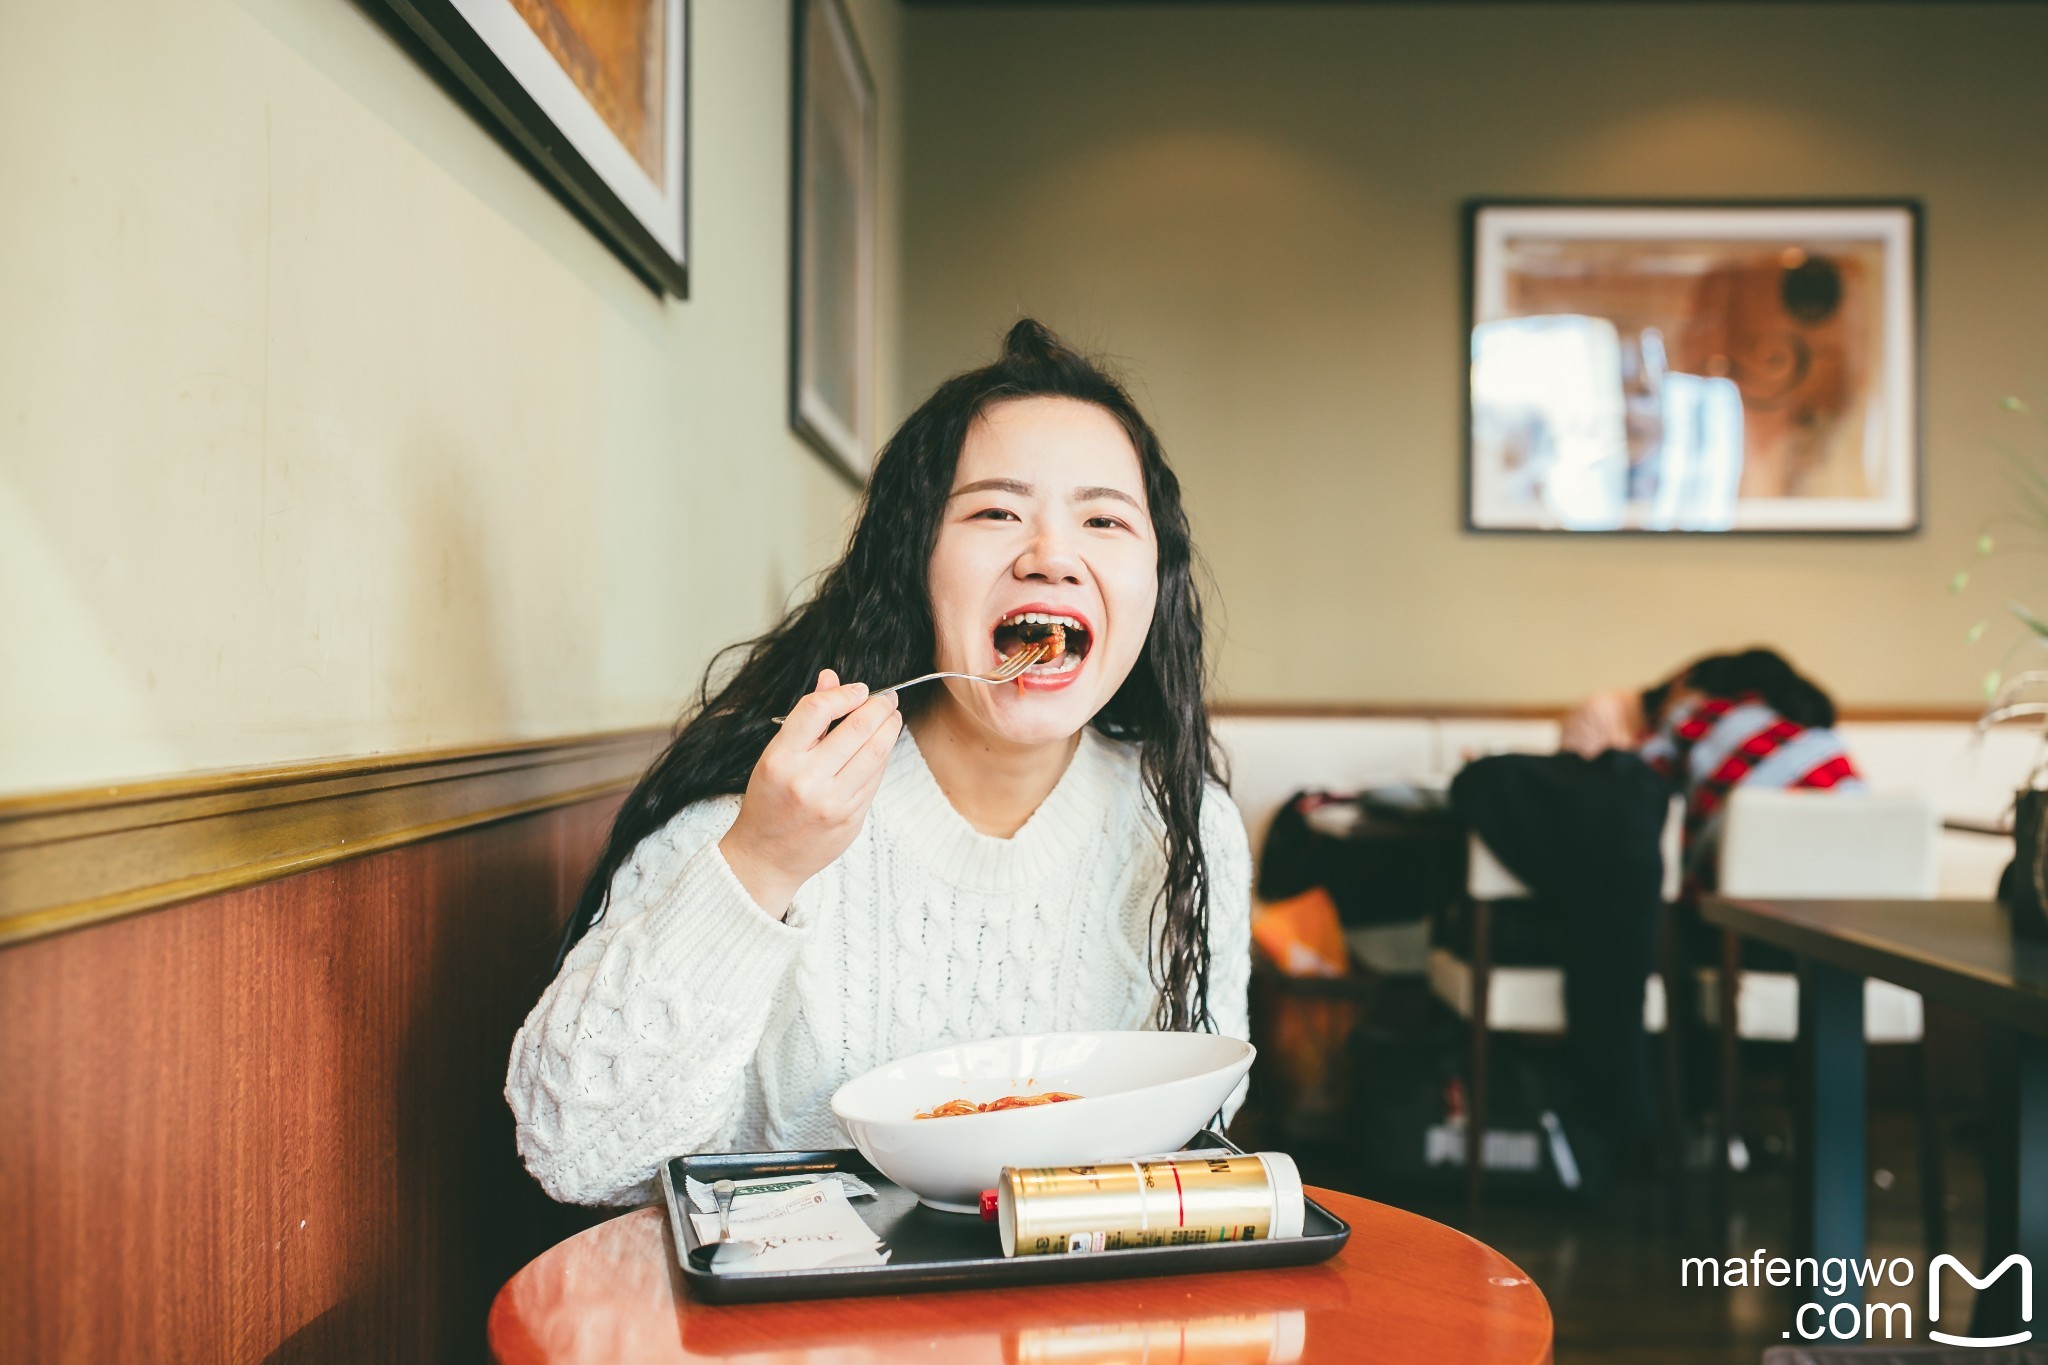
[1466,205,1919,530]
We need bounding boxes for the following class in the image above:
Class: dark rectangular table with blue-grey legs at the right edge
[1700,896,2048,1336]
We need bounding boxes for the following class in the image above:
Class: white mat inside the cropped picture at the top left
[449,0,688,264]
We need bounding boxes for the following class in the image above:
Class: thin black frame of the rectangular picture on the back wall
[1458,196,1925,538]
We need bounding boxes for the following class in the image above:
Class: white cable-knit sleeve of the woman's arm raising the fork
[506,796,809,1203]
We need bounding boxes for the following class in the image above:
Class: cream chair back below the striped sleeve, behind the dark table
[1720,786,1942,900]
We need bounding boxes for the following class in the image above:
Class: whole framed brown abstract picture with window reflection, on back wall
[1464,201,1921,534]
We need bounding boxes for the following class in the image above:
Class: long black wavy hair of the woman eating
[555,319,1223,1029]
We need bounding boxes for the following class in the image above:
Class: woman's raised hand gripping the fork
[719,669,903,919]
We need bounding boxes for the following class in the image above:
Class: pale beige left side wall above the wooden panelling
[0,0,901,792]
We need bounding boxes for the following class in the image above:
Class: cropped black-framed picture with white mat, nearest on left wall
[381,0,690,299]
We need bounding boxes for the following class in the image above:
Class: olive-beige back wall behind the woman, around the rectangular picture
[905,4,2048,704]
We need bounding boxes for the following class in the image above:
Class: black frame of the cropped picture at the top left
[362,0,690,299]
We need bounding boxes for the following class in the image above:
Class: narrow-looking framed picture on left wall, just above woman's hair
[788,0,874,483]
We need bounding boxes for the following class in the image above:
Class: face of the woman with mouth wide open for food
[932,397,1159,745]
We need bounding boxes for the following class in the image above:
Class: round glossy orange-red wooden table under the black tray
[489,1189,1550,1365]
